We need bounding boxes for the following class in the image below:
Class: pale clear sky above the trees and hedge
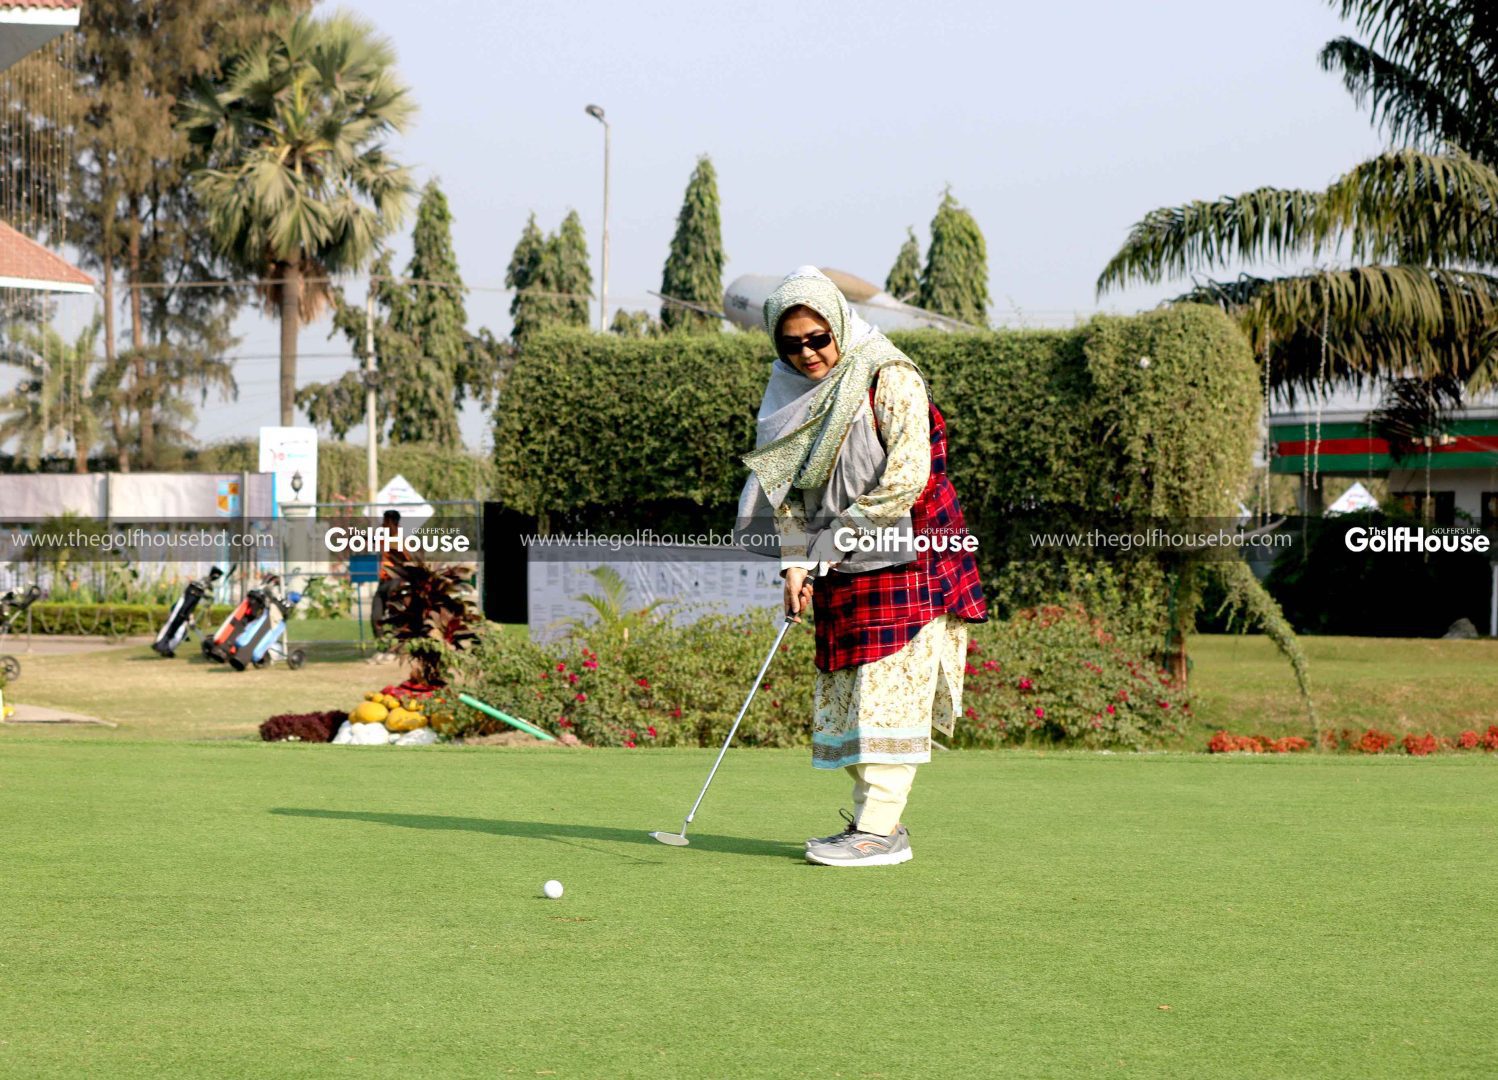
[41,0,1381,448]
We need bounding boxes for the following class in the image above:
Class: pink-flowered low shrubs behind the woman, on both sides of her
[446,607,1189,749]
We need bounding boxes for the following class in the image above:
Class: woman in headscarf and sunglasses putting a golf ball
[740,267,989,866]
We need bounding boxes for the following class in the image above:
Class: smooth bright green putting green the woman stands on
[0,740,1498,1077]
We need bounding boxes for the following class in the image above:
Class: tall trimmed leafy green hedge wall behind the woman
[494,306,1261,641]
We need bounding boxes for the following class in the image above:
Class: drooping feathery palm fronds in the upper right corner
[1098,0,1498,400]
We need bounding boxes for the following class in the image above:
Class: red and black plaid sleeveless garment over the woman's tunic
[812,378,989,671]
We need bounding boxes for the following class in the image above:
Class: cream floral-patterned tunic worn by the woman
[776,364,968,768]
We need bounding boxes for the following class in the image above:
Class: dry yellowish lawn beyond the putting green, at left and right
[0,625,1498,750]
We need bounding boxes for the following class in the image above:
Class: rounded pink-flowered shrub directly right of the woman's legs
[956,605,1191,749]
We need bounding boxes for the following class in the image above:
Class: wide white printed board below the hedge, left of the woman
[526,544,785,641]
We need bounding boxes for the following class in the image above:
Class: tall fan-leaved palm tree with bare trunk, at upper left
[180,12,415,424]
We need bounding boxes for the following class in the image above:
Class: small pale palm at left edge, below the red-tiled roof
[0,316,103,473]
